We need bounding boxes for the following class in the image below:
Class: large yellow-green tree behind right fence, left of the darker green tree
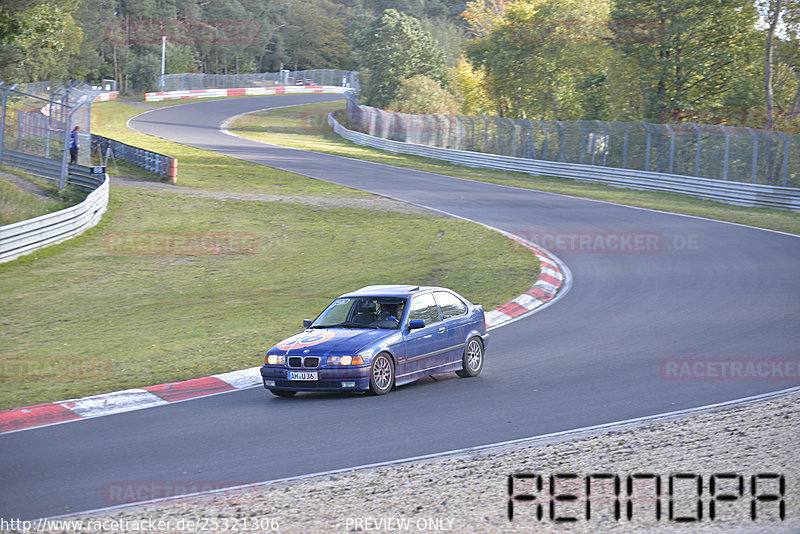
[467,0,611,120]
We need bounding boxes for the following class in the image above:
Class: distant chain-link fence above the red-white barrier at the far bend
[158,69,361,91]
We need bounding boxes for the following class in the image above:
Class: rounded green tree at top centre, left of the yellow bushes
[356,9,447,107]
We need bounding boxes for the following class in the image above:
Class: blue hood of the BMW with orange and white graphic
[269,328,398,356]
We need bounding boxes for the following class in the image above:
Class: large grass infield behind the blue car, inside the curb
[0,97,539,409]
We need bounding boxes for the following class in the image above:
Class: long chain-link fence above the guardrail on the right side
[347,93,800,188]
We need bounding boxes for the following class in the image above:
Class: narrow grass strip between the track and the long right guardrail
[230,102,800,234]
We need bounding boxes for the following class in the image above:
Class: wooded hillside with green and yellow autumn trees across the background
[0,0,800,131]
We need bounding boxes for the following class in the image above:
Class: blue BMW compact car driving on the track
[261,285,489,397]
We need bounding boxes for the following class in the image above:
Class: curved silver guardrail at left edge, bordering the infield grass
[0,162,109,263]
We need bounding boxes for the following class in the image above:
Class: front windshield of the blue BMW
[311,297,406,329]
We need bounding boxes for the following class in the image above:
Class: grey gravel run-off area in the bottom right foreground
[47,388,800,533]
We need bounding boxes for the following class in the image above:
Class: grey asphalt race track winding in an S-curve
[0,95,800,518]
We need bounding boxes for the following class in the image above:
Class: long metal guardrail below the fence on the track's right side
[328,113,800,211]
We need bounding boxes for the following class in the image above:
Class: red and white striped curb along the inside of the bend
[0,243,565,433]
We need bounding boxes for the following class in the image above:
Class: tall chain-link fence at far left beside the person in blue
[0,82,100,187]
